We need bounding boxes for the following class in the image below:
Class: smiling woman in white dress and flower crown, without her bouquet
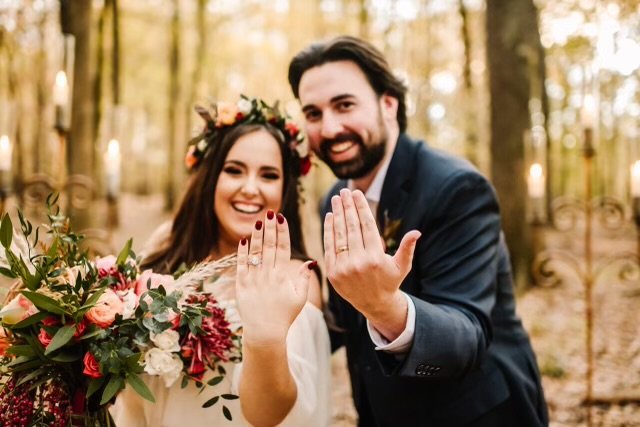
[112,98,331,427]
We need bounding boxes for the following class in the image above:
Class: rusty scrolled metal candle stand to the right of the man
[532,129,640,426]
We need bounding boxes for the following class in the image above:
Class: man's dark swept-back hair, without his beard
[289,36,407,132]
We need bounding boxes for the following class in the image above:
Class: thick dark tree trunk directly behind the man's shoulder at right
[486,0,542,287]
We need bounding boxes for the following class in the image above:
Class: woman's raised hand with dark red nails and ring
[236,210,312,345]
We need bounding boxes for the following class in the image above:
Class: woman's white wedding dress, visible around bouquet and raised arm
[111,224,331,427]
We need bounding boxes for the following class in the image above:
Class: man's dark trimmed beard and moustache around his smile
[318,118,387,179]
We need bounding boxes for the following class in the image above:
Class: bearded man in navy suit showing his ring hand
[289,37,548,427]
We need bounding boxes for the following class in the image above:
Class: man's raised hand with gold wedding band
[324,189,420,341]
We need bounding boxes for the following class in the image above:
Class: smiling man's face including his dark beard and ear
[298,61,395,179]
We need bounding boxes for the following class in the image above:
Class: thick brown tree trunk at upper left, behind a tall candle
[61,0,93,230]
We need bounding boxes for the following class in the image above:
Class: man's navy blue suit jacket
[323,135,547,427]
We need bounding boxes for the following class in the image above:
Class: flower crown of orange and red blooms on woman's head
[184,95,311,175]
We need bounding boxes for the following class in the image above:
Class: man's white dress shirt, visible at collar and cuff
[347,158,416,353]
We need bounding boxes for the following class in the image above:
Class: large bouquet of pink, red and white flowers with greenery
[0,200,241,427]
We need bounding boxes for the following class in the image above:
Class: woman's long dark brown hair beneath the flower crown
[142,124,309,274]
